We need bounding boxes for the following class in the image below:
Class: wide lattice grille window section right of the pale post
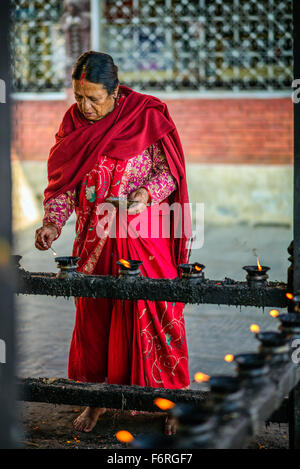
[98,0,293,91]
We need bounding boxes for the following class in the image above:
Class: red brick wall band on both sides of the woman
[12,98,293,164]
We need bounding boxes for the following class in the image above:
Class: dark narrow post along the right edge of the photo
[289,0,300,449]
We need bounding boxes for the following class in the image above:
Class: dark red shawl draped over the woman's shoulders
[44,85,192,264]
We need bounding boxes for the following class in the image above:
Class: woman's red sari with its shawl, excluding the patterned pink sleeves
[45,87,191,389]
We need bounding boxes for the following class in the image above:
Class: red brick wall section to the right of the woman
[168,98,293,164]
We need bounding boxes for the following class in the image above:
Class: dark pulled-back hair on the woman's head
[72,50,119,95]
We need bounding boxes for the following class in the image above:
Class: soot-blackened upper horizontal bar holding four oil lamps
[16,269,287,308]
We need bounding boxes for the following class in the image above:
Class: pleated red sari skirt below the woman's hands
[69,201,190,389]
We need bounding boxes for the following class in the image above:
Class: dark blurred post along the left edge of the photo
[0,0,16,449]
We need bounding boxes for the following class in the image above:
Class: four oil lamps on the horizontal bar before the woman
[49,256,270,287]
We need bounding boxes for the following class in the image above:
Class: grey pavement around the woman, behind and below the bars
[14,218,292,448]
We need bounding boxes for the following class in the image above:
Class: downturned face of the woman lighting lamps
[73,80,119,121]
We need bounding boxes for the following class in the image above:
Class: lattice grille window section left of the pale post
[12,0,65,92]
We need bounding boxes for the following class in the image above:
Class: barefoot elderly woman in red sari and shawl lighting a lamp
[35,51,191,434]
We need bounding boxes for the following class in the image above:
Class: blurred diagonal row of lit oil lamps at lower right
[116,296,300,449]
